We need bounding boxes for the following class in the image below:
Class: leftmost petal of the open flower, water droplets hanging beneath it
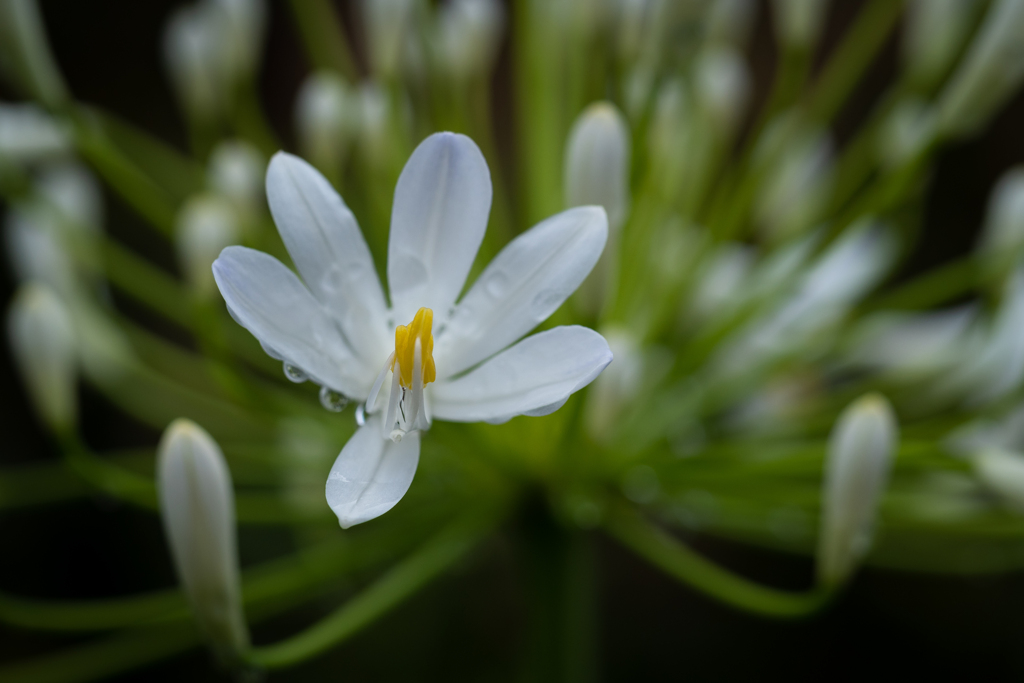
[213,247,375,399]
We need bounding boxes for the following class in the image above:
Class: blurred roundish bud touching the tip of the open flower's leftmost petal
[175,195,242,295]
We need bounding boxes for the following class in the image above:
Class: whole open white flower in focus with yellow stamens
[207,133,611,527]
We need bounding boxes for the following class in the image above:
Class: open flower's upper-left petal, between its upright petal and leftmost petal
[266,152,388,365]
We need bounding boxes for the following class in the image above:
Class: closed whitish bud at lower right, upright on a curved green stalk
[817,394,899,586]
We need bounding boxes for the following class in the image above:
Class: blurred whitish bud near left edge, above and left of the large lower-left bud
[7,283,78,431]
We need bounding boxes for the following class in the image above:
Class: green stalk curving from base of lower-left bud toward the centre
[249,511,492,669]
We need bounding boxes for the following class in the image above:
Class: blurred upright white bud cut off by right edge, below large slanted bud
[979,166,1024,273]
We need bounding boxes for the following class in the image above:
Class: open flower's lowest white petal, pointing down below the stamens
[327,415,420,528]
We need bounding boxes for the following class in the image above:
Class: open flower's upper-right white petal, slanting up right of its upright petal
[434,206,608,378]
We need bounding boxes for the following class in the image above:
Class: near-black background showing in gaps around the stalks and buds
[0,0,1024,682]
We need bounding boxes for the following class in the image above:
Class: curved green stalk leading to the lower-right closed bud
[605,508,834,618]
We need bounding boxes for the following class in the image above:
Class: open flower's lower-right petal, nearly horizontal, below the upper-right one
[430,326,611,422]
